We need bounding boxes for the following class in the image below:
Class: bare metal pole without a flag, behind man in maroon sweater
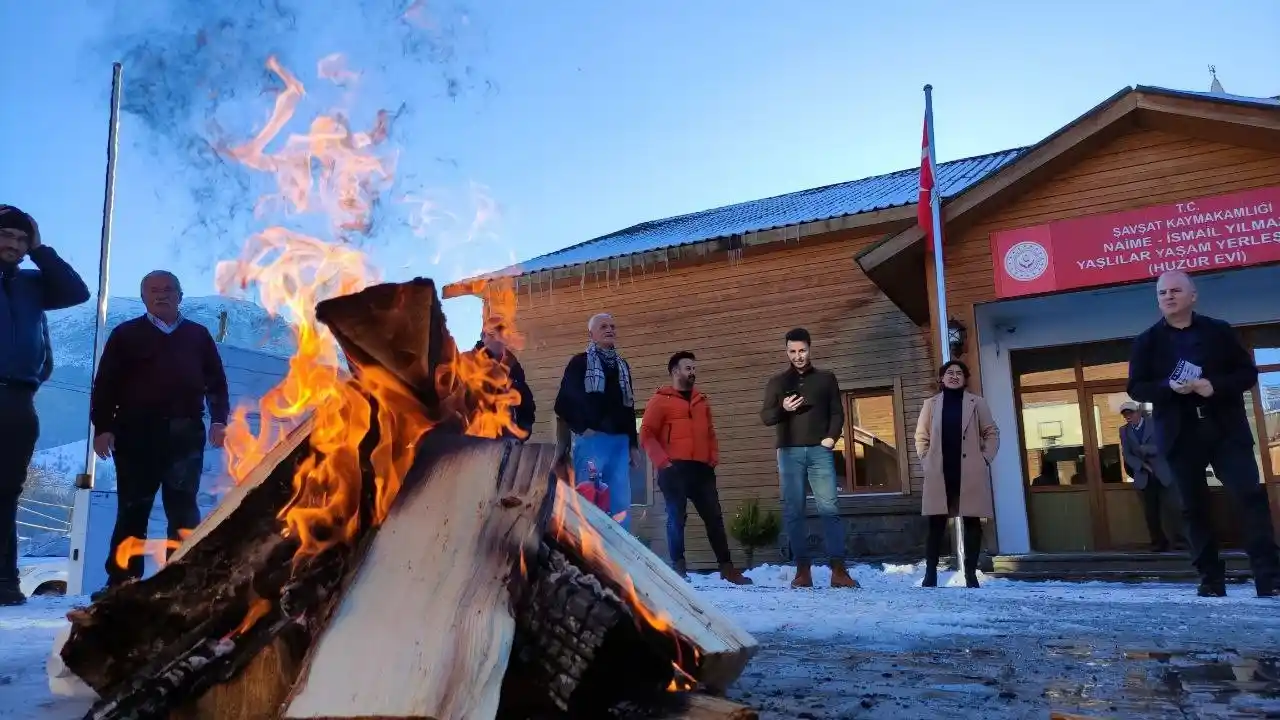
[68,63,124,594]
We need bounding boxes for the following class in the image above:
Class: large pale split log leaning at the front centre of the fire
[284,433,554,720]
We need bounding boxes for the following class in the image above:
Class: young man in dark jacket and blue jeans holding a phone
[760,328,858,588]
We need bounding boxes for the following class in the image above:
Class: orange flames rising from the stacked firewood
[216,55,521,560]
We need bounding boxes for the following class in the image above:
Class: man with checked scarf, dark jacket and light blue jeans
[556,313,640,529]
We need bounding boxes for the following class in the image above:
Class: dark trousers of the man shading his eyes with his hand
[0,383,40,591]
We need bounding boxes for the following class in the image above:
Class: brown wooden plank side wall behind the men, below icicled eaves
[518,233,936,568]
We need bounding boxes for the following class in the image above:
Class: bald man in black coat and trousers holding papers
[1129,270,1280,597]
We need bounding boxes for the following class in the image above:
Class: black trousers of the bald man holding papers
[1167,419,1280,582]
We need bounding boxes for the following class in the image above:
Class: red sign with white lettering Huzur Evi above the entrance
[991,187,1280,297]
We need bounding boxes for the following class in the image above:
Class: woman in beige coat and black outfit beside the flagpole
[915,360,1000,588]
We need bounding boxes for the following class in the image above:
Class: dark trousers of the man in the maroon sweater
[106,418,205,584]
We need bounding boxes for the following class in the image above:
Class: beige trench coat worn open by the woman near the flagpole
[915,392,1000,518]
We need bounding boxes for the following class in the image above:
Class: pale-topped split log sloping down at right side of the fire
[553,483,759,692]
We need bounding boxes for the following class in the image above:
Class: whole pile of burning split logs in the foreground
[61,281,756,720]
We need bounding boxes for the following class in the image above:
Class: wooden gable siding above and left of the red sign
[928,129,1280,379]
